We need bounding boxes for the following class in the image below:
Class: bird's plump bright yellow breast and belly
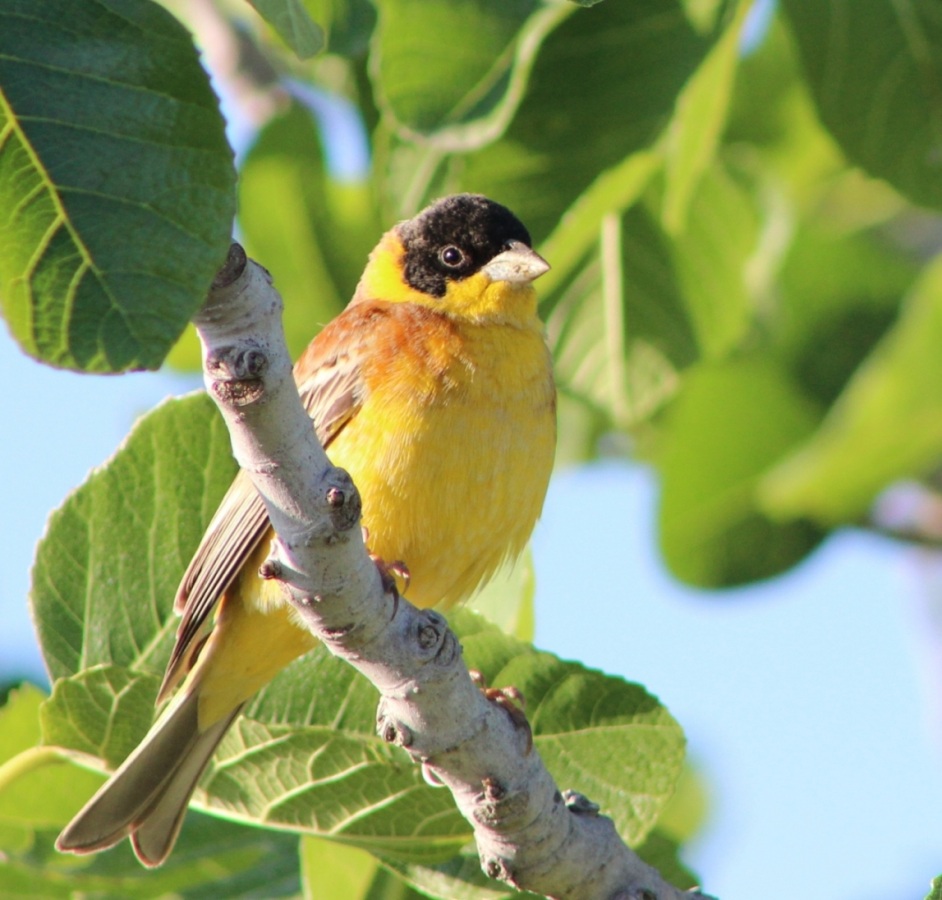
[328,311,556,606]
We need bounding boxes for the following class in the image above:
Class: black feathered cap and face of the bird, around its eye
[398,194,530,297]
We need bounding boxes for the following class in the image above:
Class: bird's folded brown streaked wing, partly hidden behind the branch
[158,310,365,703]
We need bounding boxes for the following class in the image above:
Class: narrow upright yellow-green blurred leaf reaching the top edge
[662,0,752,235]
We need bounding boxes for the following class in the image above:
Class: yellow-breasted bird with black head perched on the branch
[56,194,556,867]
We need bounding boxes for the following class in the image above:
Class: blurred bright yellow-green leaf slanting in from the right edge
[761,257,942,525]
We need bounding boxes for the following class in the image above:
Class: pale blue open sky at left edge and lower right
[0,329,942,900]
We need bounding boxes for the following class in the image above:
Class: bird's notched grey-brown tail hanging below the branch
[56,690,241,866]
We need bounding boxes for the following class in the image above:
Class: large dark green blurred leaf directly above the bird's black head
[443,0,707,242]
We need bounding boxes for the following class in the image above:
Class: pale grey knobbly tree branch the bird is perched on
[194,244,716,900]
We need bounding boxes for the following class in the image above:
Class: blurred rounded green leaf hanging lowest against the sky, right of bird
[657,356,822,587]
